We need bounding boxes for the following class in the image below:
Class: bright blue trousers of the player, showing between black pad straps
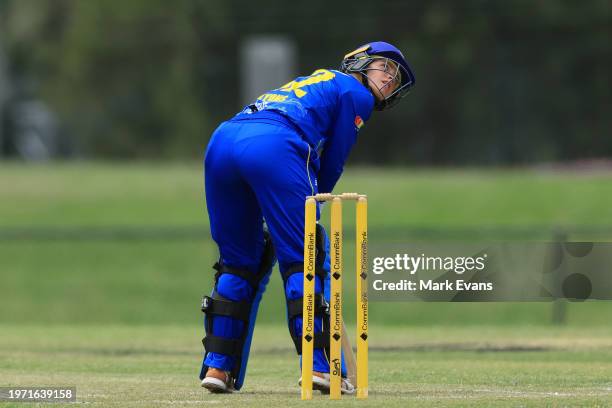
[204,118,340,372]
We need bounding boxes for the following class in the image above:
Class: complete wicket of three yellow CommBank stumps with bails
[302,193,368,400]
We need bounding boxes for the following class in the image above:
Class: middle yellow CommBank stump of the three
[329,197,342,399]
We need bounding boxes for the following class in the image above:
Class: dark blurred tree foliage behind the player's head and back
[0,0,612,164]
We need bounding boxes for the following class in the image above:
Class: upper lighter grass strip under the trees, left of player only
[0,163,207,227]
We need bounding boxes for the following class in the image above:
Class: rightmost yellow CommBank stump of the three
[356,197,368,398]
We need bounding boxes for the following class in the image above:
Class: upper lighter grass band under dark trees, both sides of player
[0,163,612,233]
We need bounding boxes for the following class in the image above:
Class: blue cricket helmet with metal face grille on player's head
[340,41,415,111]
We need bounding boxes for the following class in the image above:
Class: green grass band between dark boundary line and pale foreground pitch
[0,241,612,326]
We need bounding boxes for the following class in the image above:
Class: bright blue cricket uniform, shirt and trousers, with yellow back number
[204,70,374,380]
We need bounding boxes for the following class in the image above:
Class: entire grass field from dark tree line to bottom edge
[0,163,612,407]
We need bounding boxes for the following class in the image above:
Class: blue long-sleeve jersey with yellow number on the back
[237,69,374,193]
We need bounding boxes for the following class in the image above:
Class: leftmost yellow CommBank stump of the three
[302,197,317,400]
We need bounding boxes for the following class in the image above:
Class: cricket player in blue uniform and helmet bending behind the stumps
[200,41,415,394]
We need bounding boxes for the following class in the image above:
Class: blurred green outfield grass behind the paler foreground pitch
[0,163,612,325]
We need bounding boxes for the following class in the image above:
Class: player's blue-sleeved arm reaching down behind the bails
[318,92,374,193]
